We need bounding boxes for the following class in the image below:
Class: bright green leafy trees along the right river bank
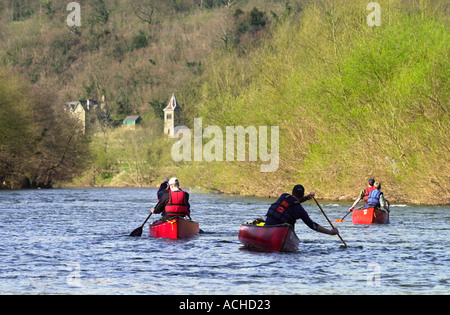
[178,1,450,203]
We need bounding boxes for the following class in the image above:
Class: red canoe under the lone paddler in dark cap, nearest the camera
[239,224,300,252]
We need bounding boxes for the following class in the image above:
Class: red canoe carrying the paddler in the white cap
[150,218,199,239]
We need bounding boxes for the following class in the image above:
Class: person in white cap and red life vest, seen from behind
[151,177,191,221]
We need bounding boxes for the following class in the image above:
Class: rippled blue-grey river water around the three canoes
[0,188,450,295]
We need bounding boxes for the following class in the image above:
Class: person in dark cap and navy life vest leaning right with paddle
[265,185,339,235]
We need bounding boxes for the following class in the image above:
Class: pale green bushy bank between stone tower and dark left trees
[73,124,173,187]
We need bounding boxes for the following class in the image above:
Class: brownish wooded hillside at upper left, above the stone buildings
[0,0,284,120]
